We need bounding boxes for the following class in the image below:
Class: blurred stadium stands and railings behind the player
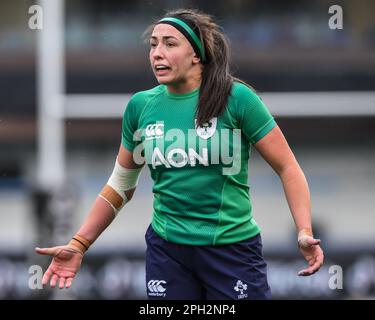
[0,0,375,299]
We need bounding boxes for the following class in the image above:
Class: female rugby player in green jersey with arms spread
[36,10,323,299]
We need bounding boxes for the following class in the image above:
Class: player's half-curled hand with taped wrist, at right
[298,235,324,276]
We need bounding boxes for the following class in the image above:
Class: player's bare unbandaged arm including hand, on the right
[254,126,324,276]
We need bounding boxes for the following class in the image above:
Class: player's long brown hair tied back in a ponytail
[143,9,252,126]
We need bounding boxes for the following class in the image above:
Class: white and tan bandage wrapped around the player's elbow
[99,159,142,216]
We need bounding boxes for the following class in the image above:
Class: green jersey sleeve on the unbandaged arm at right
[238,88,276,144]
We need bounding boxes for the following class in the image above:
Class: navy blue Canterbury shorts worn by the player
[145,225,271,300]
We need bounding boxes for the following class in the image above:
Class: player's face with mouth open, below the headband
[150,24,203,90]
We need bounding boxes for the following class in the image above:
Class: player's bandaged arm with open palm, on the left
[35,145,142,289]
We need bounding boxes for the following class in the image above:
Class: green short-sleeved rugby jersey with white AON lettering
[122,82,276,245]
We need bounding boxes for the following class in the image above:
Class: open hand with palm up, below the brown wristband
[35,245,83,289]
